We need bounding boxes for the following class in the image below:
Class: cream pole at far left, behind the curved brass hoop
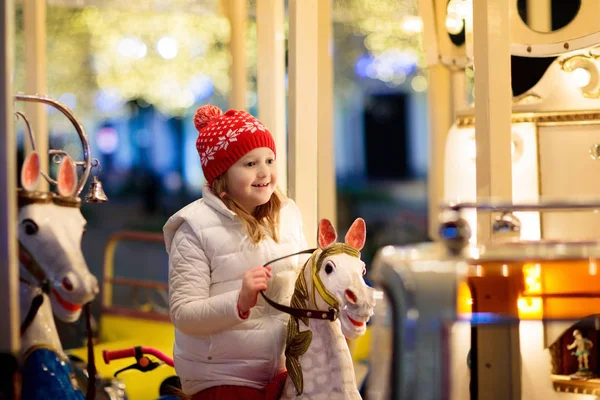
[23,0,49,191]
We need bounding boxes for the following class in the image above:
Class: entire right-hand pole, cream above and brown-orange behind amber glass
[470,0,521,400]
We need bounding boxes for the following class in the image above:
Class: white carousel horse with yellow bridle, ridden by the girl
[281,218,375,400]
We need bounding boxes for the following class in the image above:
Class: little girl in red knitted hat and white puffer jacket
[164,105,306,400]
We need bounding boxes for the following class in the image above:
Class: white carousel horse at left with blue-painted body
[18,152,98,400]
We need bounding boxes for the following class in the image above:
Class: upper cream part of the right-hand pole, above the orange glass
[473,0,512,228]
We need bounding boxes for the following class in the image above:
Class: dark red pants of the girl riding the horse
[191,372,287,400]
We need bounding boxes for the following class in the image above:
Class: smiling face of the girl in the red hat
[225,147,277,214]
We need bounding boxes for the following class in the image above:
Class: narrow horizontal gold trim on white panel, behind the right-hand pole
[456,111,600,128]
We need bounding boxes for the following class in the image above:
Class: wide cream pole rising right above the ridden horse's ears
[288,0,321,247]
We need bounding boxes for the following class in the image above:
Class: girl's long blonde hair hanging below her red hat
[210,174,285,244]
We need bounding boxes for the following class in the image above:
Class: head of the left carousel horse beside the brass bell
[18,152,98,322]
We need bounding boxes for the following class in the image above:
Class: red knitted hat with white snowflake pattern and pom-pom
[194,104,275,185]
